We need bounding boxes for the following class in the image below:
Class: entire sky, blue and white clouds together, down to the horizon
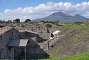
[0,0,89,20]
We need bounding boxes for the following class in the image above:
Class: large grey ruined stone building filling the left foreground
[0,26,48,60]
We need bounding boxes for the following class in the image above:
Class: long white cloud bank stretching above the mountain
[1,2,89,18]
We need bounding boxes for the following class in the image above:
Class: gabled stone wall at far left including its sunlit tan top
[0,26,19,58]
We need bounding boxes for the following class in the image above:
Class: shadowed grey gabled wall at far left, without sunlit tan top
[0,29,19,58]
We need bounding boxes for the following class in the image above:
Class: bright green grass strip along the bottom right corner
[42,52,89,60]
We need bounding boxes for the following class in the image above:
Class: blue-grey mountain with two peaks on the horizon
[35,12,89,22]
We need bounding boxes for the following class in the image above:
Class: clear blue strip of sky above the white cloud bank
[0,0,89,11]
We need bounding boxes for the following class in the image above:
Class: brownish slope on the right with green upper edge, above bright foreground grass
[49,24,89,60]
